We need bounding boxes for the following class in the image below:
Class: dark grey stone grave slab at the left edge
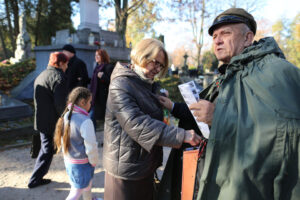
[0,93,33,121]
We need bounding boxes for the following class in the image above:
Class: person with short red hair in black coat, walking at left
[28,52,68,188]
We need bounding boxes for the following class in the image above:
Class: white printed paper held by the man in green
[178,81,210,139]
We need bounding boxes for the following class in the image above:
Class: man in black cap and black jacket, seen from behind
[63,44,90,92]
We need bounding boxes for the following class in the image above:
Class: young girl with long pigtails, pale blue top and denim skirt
[54,87,99,200]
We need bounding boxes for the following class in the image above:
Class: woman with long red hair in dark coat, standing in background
[90,49,114,128]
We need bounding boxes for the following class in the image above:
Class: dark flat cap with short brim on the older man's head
[208,8,257,35]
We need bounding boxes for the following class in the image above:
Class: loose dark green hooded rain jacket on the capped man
[195,38,300,200]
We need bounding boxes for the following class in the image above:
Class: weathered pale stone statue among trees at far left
[10,13,31,63]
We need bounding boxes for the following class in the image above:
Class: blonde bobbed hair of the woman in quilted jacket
[130,38,169,77]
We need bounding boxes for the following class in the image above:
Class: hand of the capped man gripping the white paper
[189,100,215,125]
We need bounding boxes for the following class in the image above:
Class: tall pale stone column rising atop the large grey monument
[78,0,100,32]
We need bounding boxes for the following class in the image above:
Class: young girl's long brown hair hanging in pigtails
[54,87,92,153]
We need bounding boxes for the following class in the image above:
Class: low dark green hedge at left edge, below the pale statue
[0,59,36,94]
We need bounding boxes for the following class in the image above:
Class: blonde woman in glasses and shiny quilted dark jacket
[103,39,200,200]
